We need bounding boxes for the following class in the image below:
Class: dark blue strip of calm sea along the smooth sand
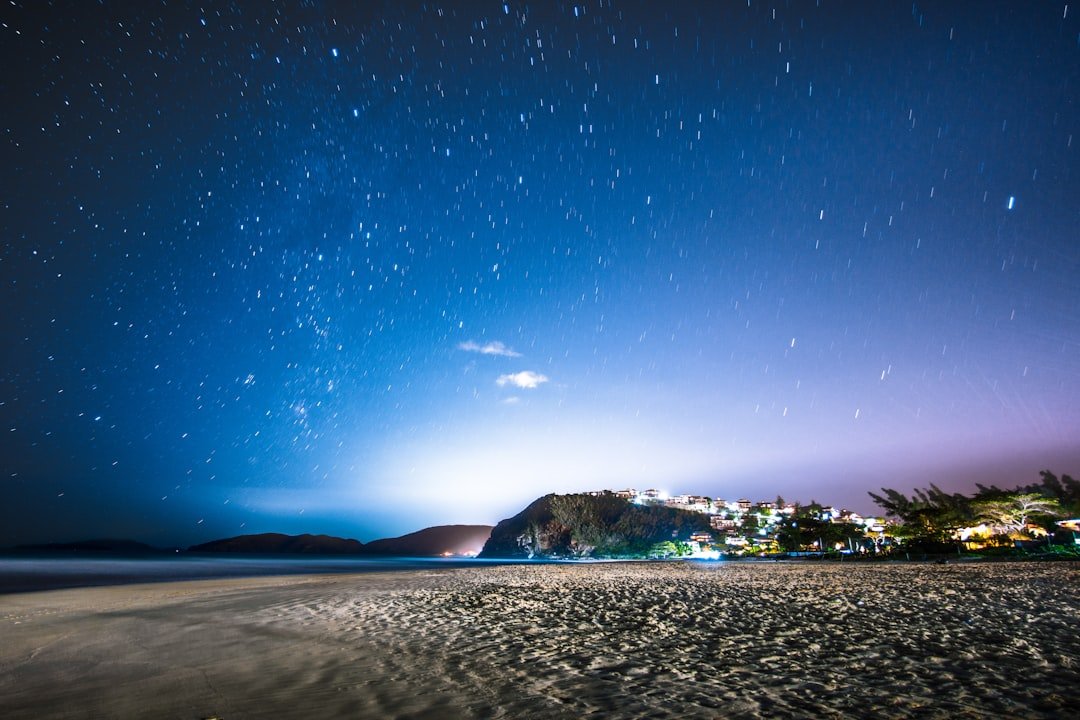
[0,553,527,594]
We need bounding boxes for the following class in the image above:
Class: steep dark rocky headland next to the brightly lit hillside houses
[480,493,710,558]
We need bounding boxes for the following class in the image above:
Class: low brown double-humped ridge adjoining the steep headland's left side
[188,525,491,557]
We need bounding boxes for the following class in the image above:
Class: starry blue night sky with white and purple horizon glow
[0,0,1080,545]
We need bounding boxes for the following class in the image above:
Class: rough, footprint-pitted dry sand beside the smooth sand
[324,563,1080,718]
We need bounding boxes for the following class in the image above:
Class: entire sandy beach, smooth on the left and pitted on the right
[0,563,1080,720]
